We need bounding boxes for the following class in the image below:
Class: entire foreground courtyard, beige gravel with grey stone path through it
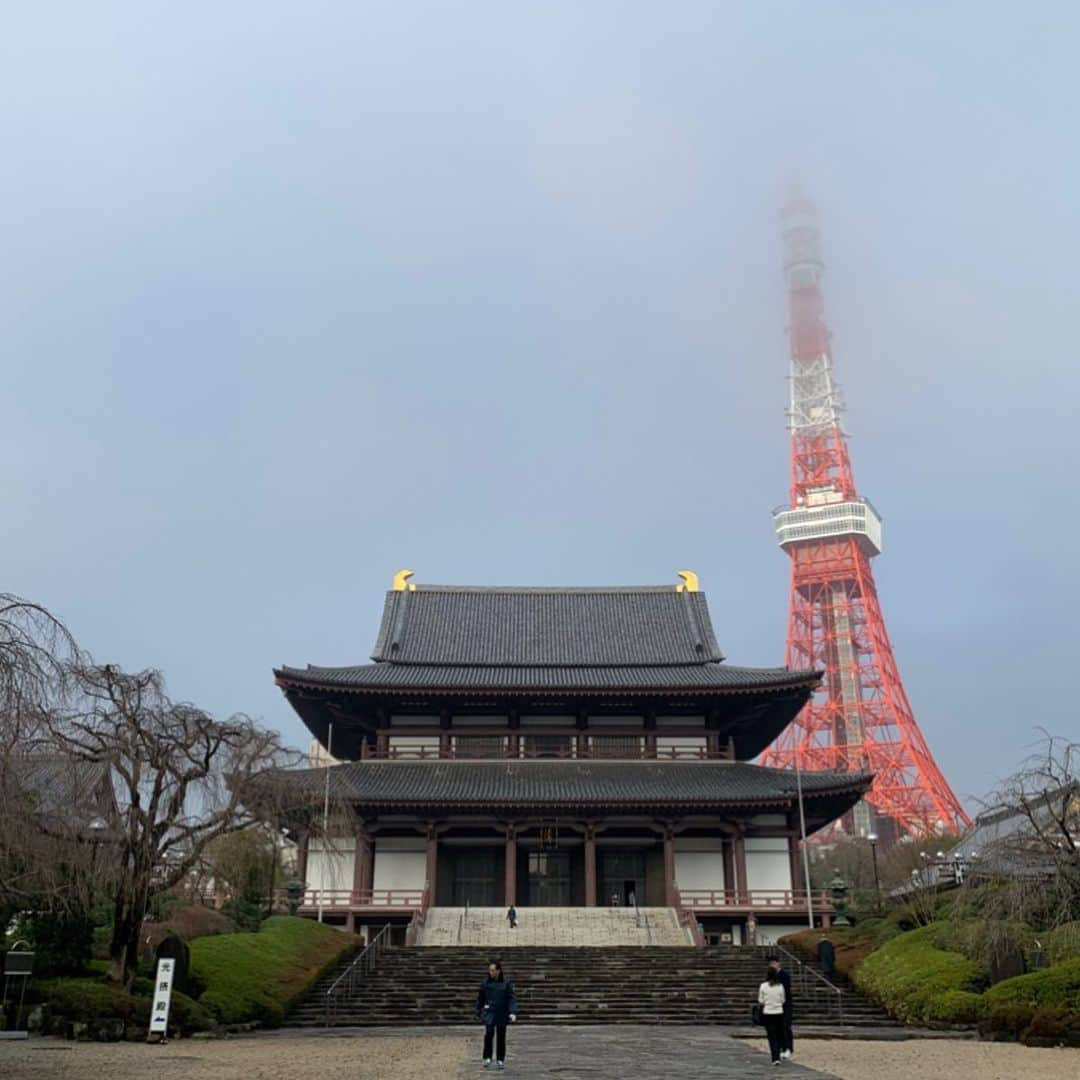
[0,1026,1080,1080]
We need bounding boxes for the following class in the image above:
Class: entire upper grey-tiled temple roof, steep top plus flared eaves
[274,585,820,693]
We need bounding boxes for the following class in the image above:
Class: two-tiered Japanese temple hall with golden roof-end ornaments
[274,570,872,944]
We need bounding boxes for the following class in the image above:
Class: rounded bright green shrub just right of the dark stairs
[854,923,986,1023]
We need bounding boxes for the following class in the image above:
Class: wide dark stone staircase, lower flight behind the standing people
[288,945,895,1028]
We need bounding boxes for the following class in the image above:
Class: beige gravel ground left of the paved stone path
[0,1036,475,1080]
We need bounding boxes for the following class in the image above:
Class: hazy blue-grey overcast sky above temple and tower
[0,0,1080,807]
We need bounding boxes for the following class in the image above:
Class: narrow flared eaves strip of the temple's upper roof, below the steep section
[274,662,820,693]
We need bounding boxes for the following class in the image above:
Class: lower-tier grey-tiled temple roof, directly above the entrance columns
[274,760,873,812]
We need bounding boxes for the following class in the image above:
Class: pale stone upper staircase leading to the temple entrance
[417,907,693,951]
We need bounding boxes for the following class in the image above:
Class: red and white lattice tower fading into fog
[762,197,970,835]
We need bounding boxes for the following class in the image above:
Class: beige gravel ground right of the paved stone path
[747,1032,1080,1080]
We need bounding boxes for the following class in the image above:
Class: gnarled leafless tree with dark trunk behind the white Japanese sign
[45,665,302,982]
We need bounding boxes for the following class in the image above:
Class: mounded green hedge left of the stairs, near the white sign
[191,915,359,1027]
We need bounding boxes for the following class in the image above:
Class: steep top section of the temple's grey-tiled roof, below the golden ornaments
[372,585,724,667]
